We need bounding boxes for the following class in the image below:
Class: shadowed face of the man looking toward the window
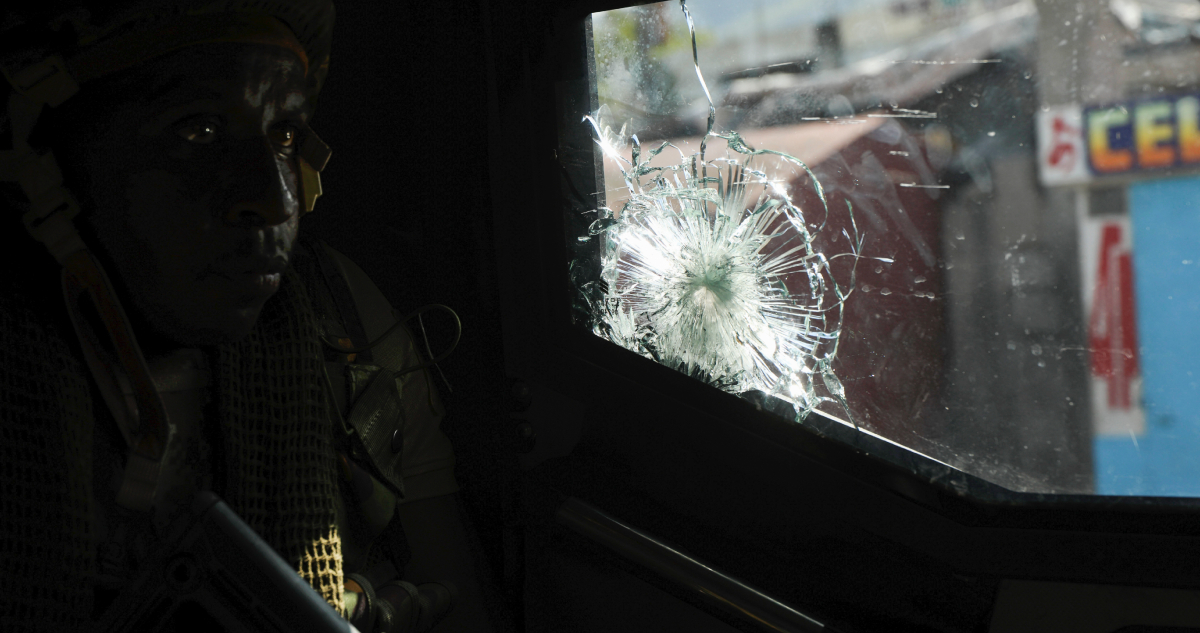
[59,44,307,345]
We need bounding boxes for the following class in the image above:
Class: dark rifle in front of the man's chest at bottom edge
[96,492,359,633]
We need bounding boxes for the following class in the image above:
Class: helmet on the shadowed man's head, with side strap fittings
[0,0,334,263]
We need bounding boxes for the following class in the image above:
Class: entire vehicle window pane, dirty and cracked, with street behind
[560,0,1200,496]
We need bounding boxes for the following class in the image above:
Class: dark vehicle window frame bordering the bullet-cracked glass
[485,0,1200,599]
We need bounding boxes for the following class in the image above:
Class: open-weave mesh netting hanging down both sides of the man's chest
[0,272,343,632]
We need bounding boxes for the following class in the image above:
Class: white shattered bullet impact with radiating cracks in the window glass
[580,0,863,427]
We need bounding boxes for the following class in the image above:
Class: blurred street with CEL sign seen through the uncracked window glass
[568,0,1200,496]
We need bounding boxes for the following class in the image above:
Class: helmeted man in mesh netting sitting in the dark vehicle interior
[0,0,491,633]
